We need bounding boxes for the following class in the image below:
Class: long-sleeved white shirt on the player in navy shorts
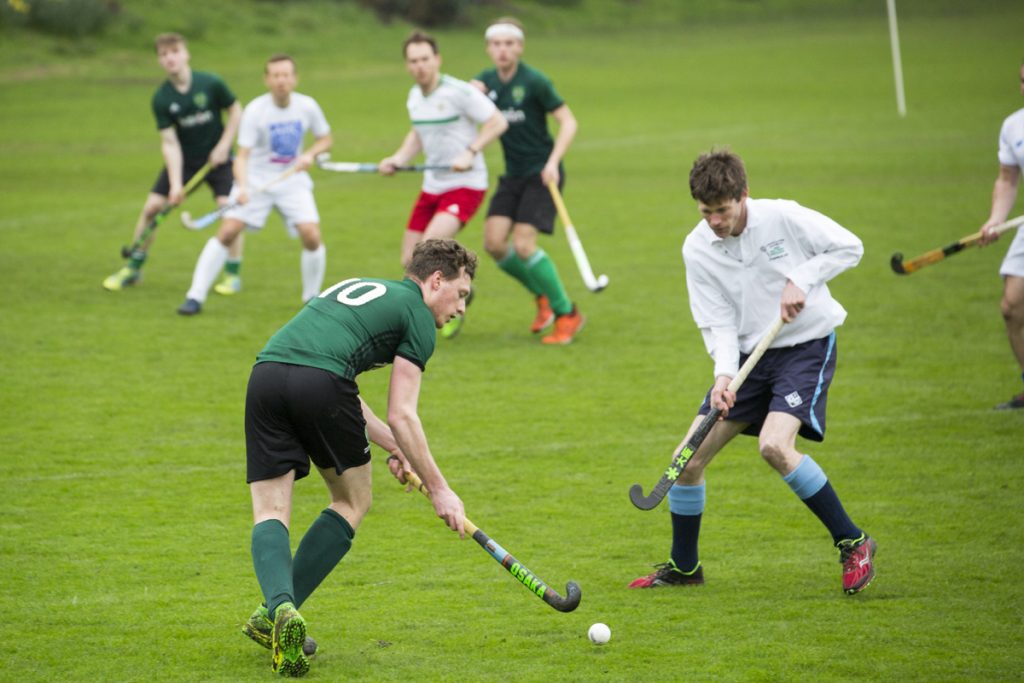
[683,199,864,377]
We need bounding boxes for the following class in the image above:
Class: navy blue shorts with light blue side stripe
[698,332,836,441]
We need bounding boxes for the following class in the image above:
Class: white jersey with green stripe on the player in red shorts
[406,74,498,195]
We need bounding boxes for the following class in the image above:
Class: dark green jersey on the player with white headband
[476,61,565,178]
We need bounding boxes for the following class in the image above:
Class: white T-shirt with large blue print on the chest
[239,92,331,189]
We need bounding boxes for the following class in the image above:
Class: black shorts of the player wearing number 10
[246,362,370,483]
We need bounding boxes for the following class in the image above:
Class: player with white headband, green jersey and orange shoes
[472,17,586,344]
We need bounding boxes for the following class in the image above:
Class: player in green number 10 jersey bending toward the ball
[243,240,476,676]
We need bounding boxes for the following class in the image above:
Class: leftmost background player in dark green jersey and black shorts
[103,33,242,294]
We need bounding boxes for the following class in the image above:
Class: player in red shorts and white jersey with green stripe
[379,31,508,337]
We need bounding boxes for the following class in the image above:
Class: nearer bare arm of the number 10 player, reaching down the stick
[387,356,466,538]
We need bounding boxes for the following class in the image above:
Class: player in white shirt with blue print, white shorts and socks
[178,54,332,315]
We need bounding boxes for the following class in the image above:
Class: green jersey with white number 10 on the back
[256,278,437,380]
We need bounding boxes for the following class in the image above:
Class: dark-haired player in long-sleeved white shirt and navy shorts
[630,152,876,595]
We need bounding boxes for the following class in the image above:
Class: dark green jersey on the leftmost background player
[153,71,234,161]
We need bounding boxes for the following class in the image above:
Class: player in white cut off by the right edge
[981,58,1024,410]
